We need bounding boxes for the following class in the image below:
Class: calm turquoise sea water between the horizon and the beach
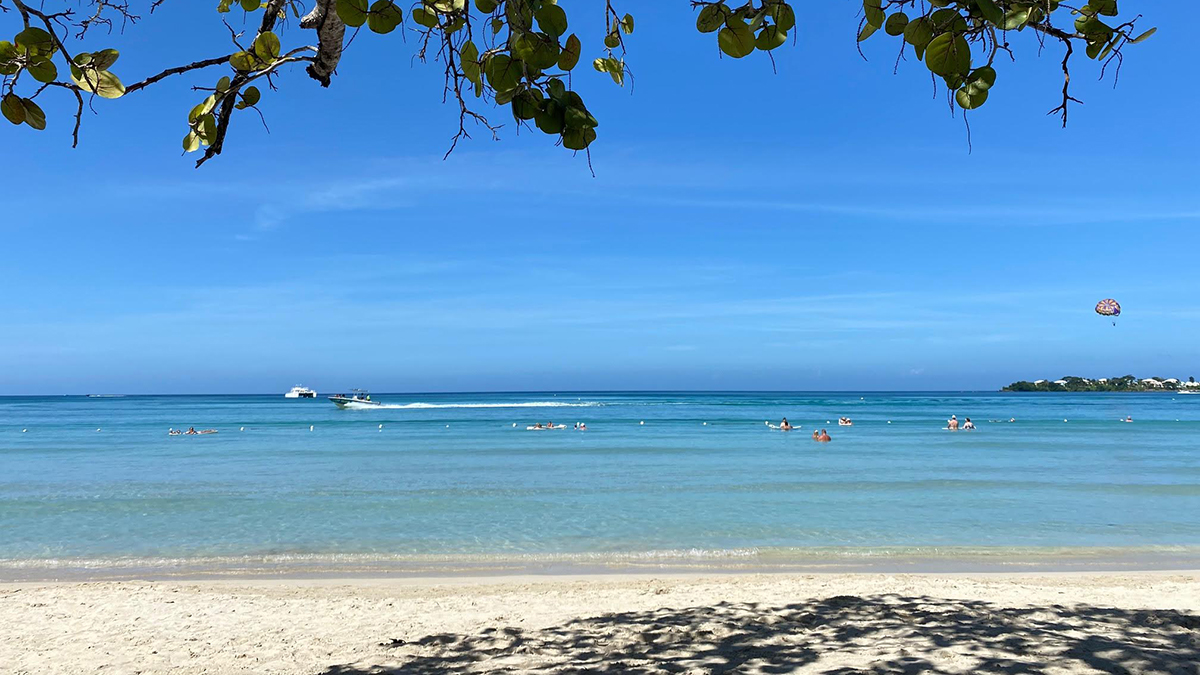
[0,393,1200,577]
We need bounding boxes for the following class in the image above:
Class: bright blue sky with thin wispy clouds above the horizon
[0,0,1200,395]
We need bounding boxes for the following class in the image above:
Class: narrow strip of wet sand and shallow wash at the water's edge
[0,546,1200,584]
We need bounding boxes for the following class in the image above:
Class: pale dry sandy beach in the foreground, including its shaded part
[0,572,1200,675]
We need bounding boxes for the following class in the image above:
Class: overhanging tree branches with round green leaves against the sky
[0,0,1154,166]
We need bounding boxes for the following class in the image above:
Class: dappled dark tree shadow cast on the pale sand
[323,596,1200,675]
